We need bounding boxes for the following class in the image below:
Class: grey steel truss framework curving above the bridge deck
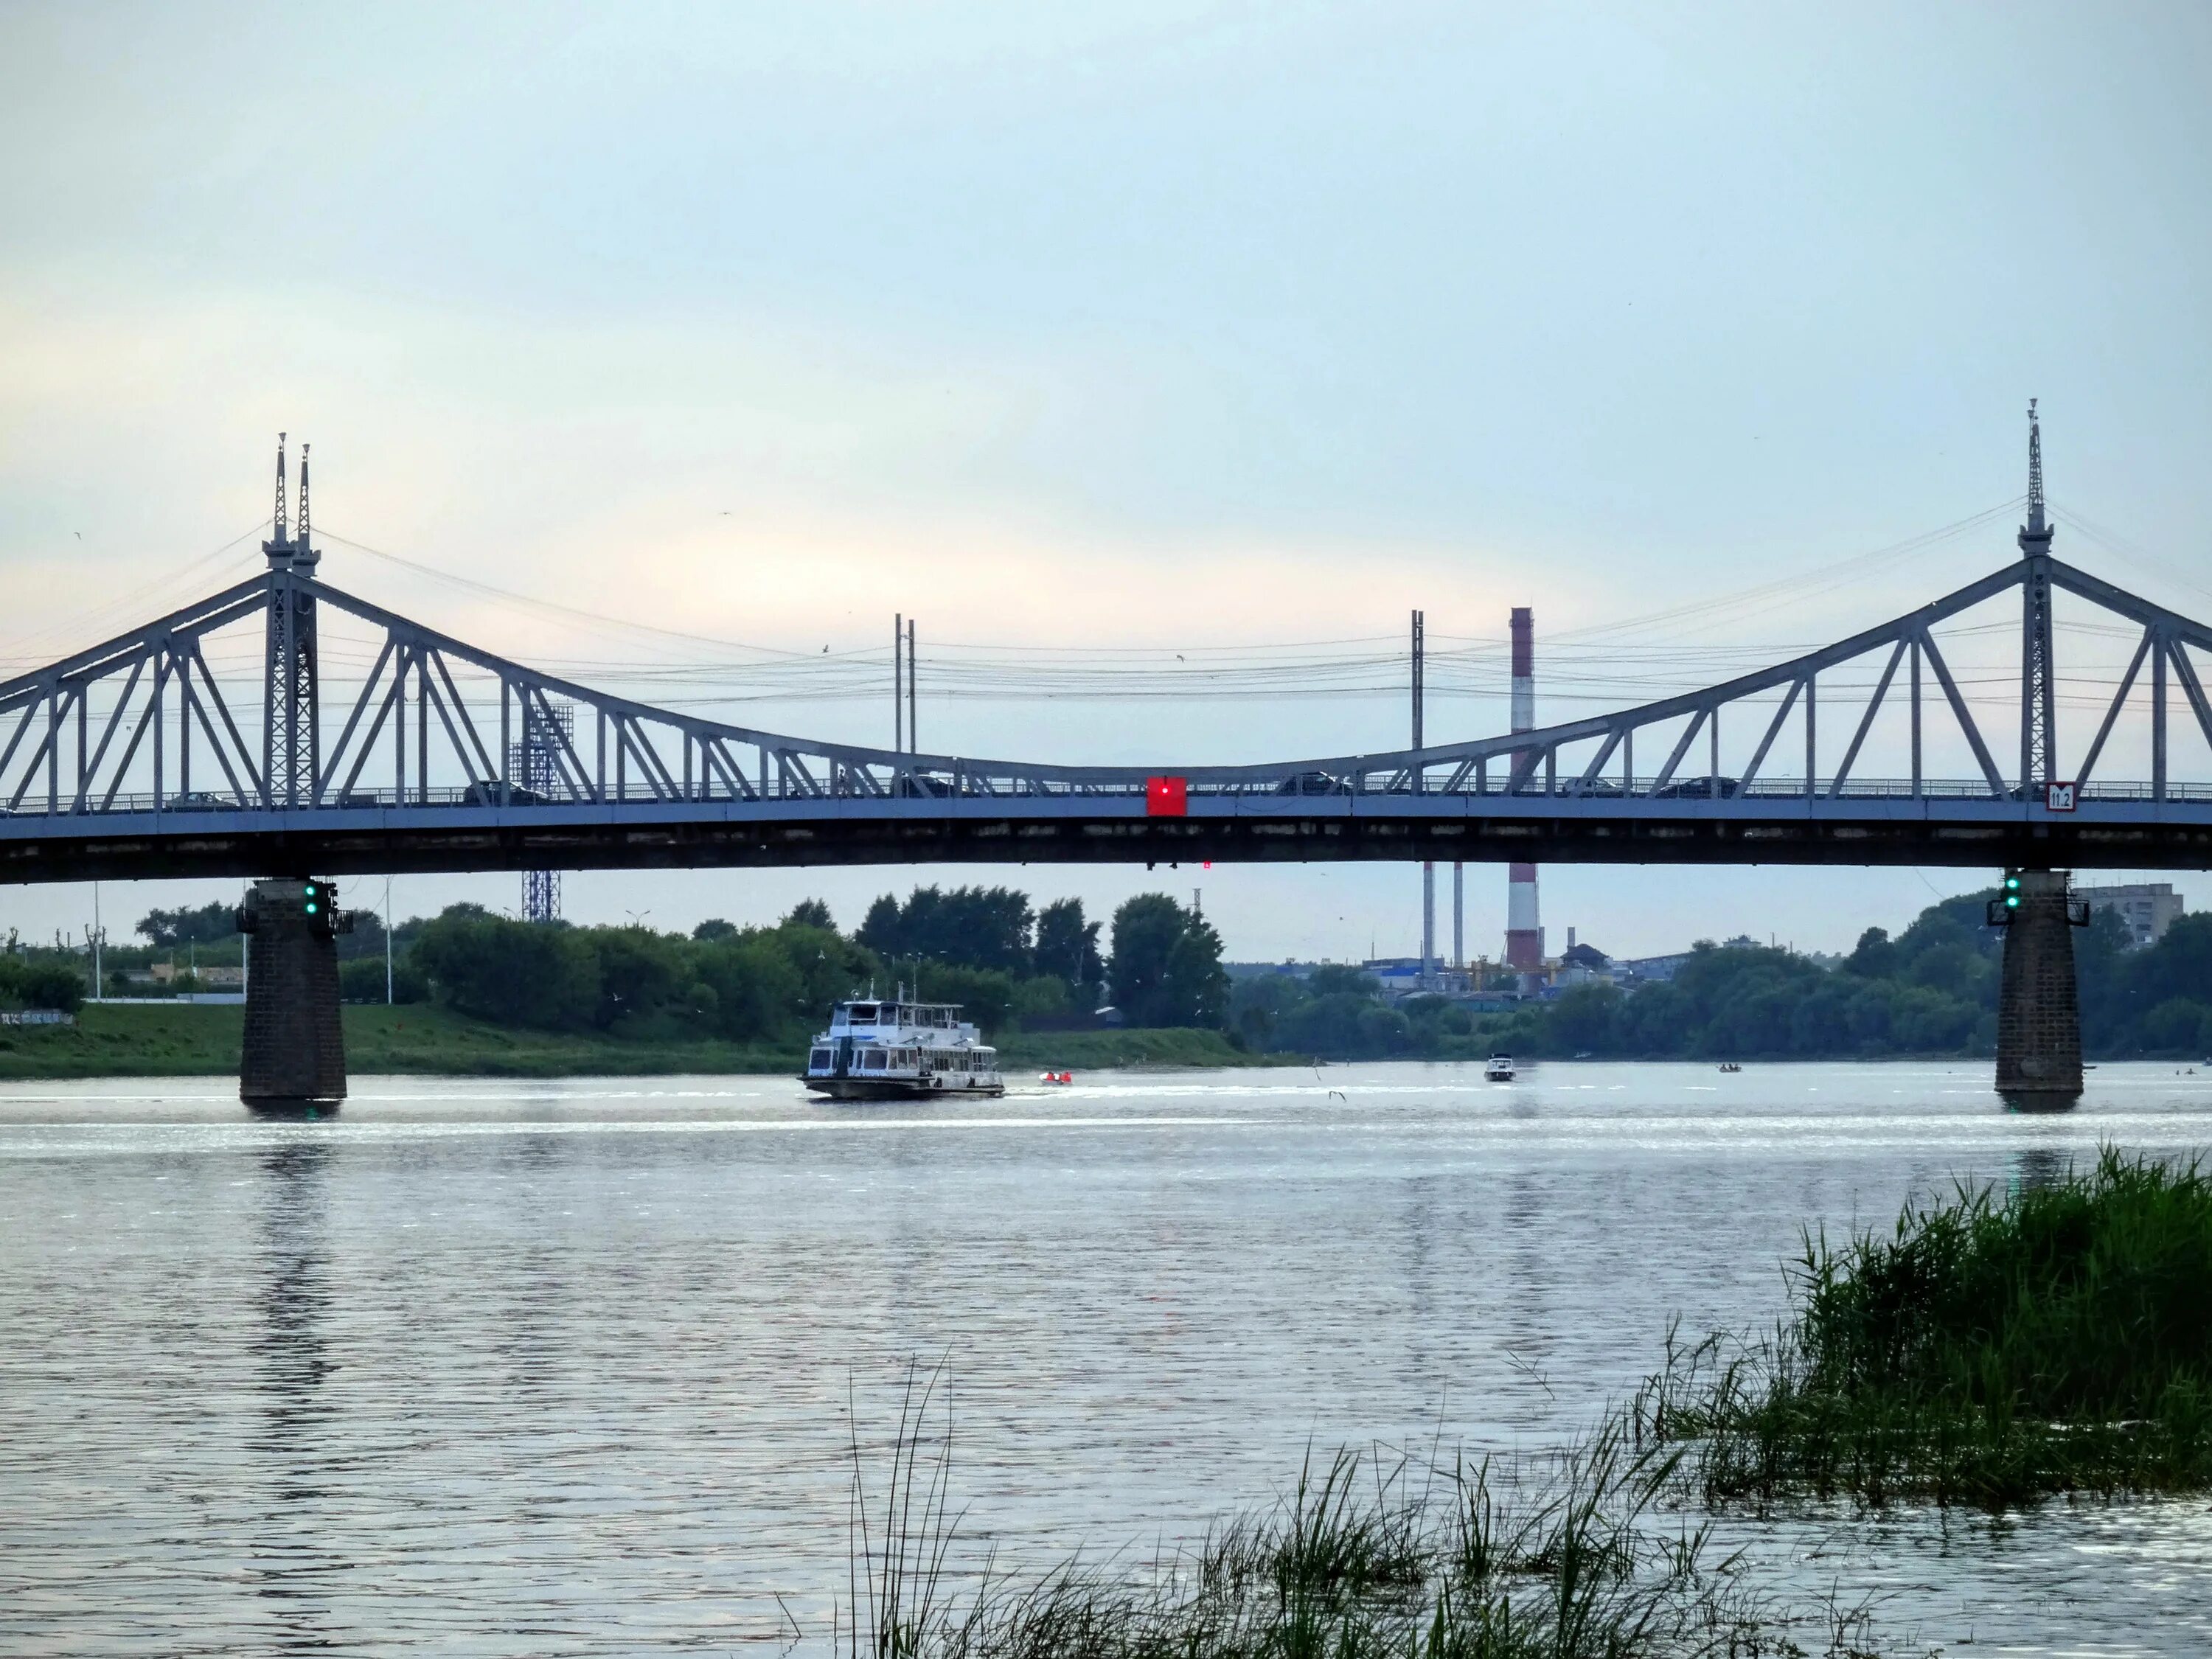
[0,551,2212,878]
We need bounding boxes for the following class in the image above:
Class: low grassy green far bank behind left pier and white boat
[0,1002,1285,1082]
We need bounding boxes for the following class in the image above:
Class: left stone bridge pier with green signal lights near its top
[239,876,347,1117]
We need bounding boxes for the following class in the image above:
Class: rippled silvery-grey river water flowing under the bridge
[0,1064,2212,1655]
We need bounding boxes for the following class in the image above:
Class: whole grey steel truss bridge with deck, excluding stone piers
[0,436,2212,883]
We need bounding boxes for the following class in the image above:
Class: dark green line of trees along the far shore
[21,885,2212,1060]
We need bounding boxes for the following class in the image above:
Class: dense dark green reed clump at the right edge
[1632,1148,2212,1509]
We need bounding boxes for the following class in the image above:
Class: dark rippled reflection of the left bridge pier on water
[246,1135,341,1652]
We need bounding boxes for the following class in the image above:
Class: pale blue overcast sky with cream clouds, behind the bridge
[0,0,2212,958]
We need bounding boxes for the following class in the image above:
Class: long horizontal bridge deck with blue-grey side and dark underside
[0,785,2212,883]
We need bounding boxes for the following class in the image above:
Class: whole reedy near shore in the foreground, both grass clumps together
[843,1148,2212,1659]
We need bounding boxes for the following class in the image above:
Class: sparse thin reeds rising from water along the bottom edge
[834,1374,1911,1659]
